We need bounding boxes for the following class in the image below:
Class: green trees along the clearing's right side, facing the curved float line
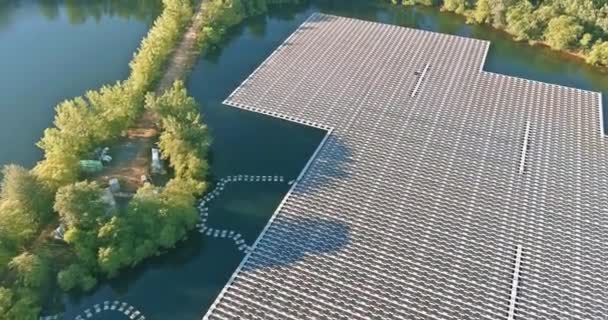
[91,81,210,276]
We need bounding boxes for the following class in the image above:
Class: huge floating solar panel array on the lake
[205,14,608,320]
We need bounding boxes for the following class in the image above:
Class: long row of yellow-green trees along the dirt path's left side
[34,0,193,189]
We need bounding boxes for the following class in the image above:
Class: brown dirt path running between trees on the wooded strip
[98,0,207,194]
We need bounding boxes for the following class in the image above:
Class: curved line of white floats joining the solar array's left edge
[196,174,285,253]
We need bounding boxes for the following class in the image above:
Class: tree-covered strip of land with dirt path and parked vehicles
[0,0,274,320]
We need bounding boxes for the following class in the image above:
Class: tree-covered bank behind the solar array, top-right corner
[391,0,608,67]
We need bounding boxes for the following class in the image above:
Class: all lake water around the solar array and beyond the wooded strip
[0,0,608,320]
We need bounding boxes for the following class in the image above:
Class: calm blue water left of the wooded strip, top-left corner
[0,0,160,166]
